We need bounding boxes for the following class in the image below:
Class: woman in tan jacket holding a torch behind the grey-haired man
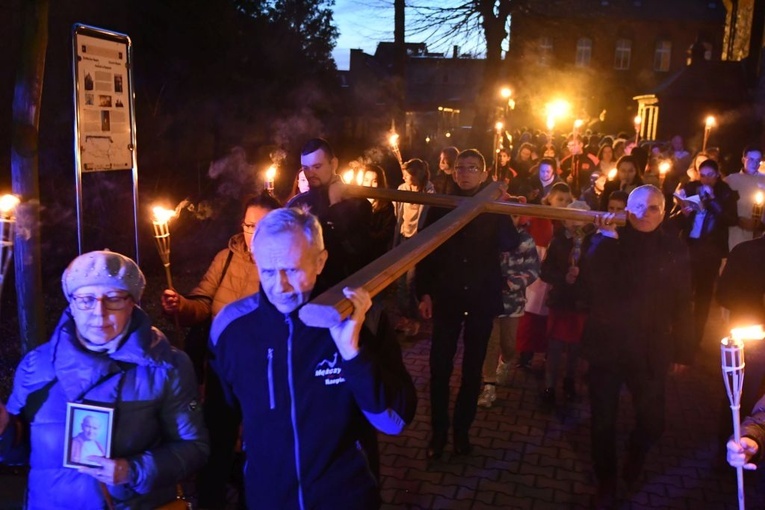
[162,192,281,508]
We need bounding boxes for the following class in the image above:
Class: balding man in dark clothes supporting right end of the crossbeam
[581,185,695,508]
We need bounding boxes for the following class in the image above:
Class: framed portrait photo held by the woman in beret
[64,402,114,468]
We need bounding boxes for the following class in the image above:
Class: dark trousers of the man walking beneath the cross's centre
[430,309,494,437]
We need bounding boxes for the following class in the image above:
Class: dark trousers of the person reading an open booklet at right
[688,239,722,345]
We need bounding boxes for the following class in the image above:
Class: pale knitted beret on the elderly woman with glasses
[61,250,146,303]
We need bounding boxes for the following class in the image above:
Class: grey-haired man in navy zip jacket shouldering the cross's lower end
[211,209,416,509]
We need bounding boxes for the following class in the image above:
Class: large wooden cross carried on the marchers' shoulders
[299,183,626,328]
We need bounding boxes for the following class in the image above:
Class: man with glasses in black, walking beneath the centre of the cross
[415,149,519,459]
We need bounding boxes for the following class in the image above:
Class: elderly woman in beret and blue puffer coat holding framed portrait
[0,251,208,510]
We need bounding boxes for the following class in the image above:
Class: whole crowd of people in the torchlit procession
[0,129,765,510]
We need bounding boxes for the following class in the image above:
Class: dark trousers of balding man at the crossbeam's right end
[589,365,667,483]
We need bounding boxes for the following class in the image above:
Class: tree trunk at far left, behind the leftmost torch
[11,0,49,352]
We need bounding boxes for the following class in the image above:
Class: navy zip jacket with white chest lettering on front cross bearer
[211,292,416,510]
